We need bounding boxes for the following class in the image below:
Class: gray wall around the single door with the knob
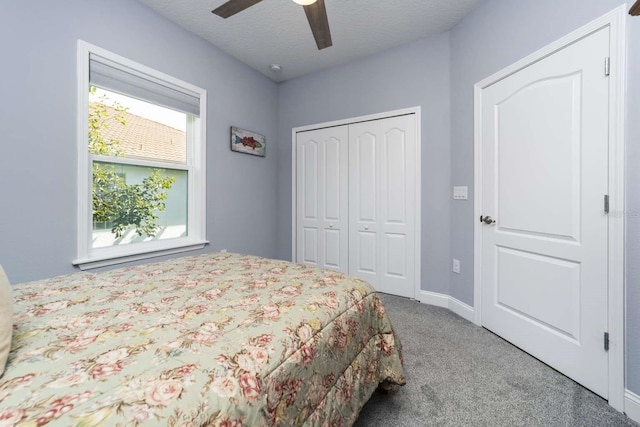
[450,0,640,393]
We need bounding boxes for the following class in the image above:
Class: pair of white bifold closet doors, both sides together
[296,114,417,297]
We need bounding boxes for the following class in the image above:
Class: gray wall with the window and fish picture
[0,0,278,283]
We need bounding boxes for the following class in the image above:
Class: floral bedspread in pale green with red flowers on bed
[0,253,405,427]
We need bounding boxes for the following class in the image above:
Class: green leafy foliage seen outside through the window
[89,86,176,238]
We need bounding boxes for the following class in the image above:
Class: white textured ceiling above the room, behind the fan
[139,0,478,82]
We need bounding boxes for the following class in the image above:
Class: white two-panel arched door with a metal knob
[476,28,609,398]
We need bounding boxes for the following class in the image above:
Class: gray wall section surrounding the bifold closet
[278,34,451,293]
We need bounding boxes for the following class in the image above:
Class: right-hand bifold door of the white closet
[349,115,417,297]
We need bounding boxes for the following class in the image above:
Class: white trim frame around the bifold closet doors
[291,106,422,299]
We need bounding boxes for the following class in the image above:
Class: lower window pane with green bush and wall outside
[92,162,187,248]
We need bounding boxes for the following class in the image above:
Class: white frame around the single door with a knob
[474,4,626,412]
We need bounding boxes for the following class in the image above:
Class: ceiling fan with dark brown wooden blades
[211,0,333,50]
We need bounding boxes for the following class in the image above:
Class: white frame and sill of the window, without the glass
[73,40,209,270]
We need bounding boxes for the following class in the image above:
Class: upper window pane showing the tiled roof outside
[89,86,187,164]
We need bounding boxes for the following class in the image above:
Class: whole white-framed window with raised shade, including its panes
[74,41,207,269]
